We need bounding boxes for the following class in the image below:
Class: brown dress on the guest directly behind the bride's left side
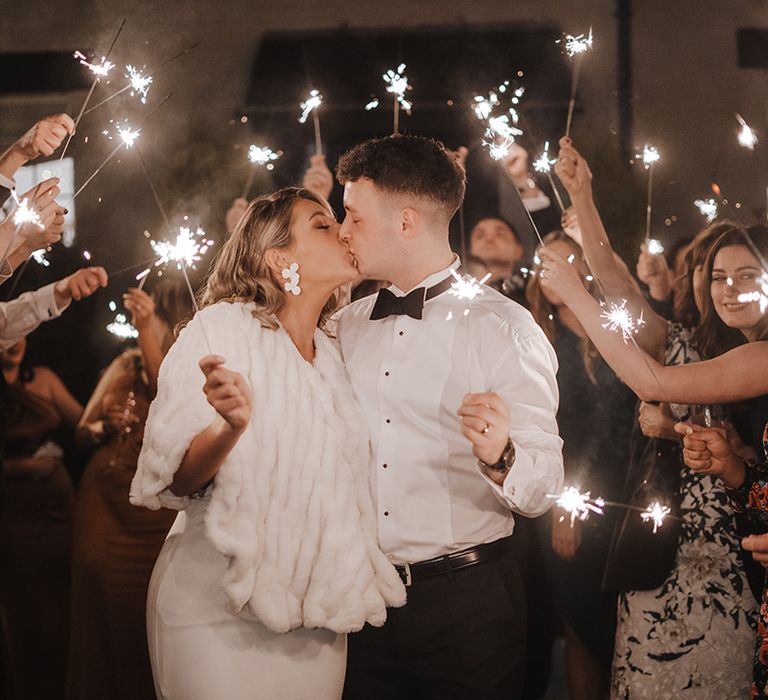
[67,350,176,700]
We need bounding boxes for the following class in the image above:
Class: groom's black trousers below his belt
[344,547,526,700]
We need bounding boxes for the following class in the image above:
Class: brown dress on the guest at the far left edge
[0,383,74,700]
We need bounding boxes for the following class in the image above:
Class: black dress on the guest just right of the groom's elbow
[536,323,636,671]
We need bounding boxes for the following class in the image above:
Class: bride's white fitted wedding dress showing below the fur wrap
[147,499,347,700]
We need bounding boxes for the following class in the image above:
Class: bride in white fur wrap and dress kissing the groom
[131,188,405,700]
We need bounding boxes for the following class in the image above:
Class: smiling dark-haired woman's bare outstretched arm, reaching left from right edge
[541,250,768,404]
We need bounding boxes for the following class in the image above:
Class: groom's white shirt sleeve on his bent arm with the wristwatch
[478,332,563,517]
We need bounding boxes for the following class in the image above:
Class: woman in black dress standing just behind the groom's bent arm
[526,231,635,700]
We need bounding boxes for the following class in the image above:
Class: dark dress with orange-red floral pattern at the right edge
[728,418,768,700]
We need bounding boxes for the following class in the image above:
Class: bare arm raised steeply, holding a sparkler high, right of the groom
[555,138,667,359]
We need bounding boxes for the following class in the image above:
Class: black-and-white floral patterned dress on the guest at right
[611,324,756,700]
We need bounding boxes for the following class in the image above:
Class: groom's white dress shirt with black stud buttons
[337,259,563,563]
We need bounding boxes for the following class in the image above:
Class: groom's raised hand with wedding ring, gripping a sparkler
[458,392,511,464]
